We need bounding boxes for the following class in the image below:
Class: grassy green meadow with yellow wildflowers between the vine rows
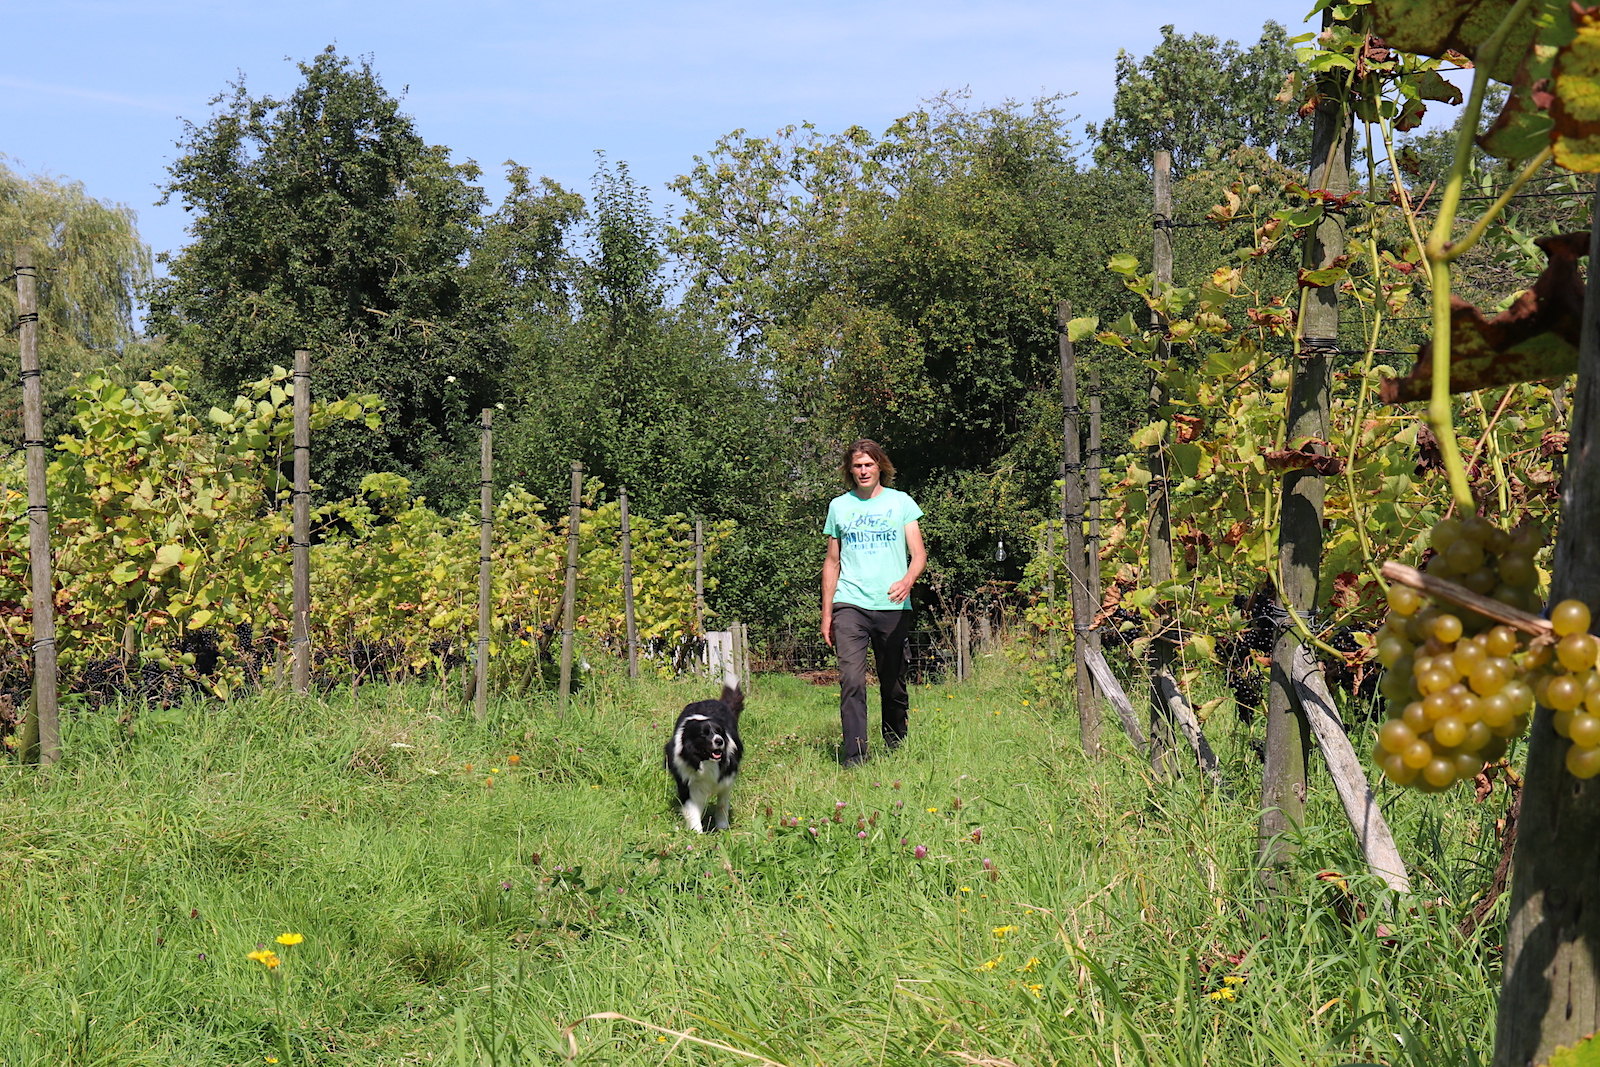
[0,656,1504,1067]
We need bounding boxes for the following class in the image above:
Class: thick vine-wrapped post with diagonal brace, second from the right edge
[1258,11,1350,881]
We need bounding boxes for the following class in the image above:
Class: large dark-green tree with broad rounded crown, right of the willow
[150,46,504,494]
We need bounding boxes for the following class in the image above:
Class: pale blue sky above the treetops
[9,0,1337,267]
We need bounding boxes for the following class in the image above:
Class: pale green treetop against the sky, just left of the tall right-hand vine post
[1088,22,1310,174]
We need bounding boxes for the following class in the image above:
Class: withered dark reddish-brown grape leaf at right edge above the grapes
[1379,232,1589,403]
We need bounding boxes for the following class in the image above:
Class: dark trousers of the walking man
[834,605,910,763]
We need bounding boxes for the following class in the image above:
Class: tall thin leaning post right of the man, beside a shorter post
[1056,301,1102,757]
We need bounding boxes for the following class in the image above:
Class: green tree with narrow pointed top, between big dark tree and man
[475,157,786,619]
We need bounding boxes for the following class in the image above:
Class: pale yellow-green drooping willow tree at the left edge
[0,162,150,450]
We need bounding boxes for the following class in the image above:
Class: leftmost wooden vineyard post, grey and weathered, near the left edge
[16,253,61,766]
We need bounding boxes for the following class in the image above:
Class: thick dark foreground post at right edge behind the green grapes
[1494,183,1600,1067]
